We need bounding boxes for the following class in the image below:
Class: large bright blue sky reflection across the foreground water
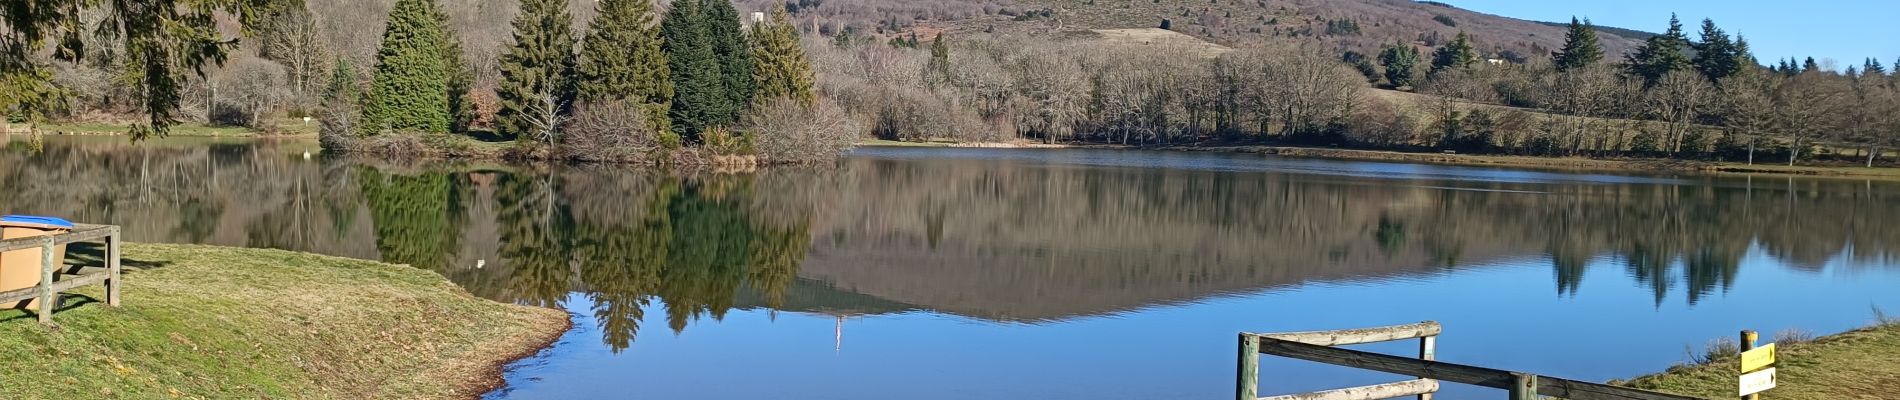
[507,242,1900,398]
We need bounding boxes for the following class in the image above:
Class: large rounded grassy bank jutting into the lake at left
[0,245,568,398]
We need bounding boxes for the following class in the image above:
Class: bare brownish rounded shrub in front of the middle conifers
[561,100,678,163]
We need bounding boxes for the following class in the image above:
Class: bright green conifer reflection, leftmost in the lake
[357,167,466,269]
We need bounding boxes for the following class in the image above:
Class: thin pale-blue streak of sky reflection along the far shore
[851,148,1680,184]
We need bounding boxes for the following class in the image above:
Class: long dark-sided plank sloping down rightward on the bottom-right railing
[1260,337,1697,400]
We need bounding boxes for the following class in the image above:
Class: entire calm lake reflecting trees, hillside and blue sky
[0,138,1900,400]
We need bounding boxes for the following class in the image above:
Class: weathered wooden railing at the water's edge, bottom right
[1235,322,1697,400]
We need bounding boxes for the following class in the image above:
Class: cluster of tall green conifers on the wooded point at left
[325,0,832,163]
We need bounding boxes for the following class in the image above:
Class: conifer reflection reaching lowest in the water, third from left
[574,184,678,353]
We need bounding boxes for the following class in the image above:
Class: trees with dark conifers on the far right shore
[1368,17,1900,165]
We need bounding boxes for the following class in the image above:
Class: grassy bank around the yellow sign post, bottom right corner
[1623,324,1900,400]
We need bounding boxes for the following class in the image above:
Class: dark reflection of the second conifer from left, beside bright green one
[494,173,574,307]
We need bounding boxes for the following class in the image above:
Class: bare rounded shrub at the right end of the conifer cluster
[741,99,865,163]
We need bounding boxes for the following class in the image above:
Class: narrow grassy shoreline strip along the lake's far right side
[859,140,1900,180]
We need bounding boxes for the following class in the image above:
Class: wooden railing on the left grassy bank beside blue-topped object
[0,224,124,324]
